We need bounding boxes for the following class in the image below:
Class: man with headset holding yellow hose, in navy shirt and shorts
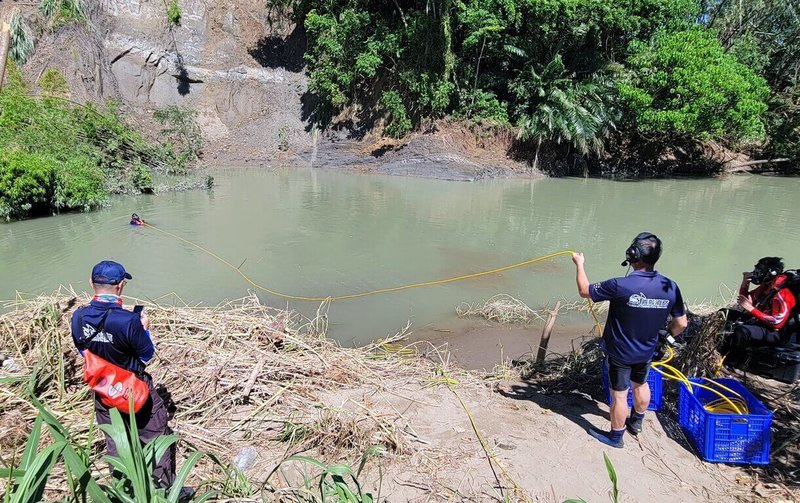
[572,232,688,448]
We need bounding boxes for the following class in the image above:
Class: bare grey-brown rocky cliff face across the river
[27,0,311,162]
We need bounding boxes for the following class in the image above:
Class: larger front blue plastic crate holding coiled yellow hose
[678,378,772,465]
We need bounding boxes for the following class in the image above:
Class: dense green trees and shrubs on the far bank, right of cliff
[272,0,800,171]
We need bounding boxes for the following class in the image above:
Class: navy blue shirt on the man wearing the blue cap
[72,299,155,384]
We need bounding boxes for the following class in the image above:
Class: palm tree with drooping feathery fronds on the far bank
[509,55,619,169]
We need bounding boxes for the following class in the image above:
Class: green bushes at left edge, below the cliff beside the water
[0,67,200,219]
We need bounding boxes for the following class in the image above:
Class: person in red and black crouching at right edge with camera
[727,257,797,351]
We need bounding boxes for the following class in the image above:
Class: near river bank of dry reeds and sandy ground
[0,292,796,501]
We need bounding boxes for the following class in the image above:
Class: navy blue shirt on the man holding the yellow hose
[589,271,685,365]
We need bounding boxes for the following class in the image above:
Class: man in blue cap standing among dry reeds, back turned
[72,260,175,494]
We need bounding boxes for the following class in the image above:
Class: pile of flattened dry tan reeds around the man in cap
[0,290,456,500]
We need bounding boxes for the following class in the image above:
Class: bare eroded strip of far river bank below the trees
[204,120,800,182]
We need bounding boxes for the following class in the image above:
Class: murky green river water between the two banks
[0,168,800,366]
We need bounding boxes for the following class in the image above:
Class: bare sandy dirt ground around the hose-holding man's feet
[302,366,780,502]
